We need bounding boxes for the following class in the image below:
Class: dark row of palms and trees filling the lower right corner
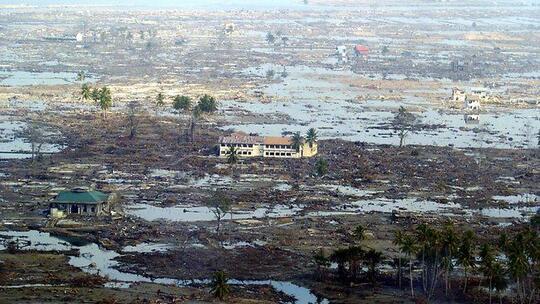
[313,216,540,304]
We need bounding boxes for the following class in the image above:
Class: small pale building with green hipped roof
[50,187,110,218]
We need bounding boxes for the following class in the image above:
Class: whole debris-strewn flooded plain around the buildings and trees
[0,0,540,304]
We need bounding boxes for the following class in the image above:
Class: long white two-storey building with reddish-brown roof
[219,133,318,158]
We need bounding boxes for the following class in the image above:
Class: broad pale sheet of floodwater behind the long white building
[222,65,540,148]
